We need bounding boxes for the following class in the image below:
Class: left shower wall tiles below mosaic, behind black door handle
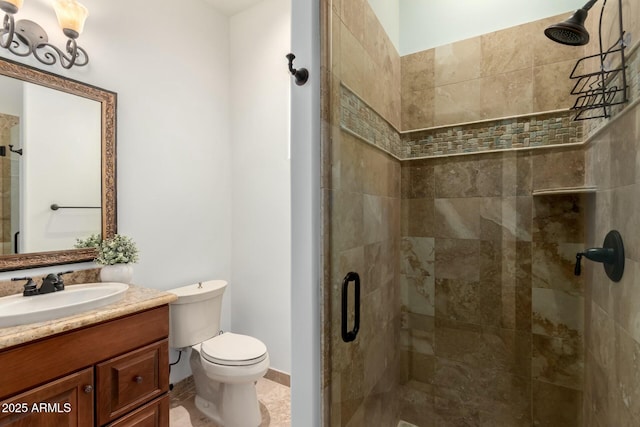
[325,136,400,427]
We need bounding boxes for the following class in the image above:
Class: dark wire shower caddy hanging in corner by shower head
[571,0,629,120]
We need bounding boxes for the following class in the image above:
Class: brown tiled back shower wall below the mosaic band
[400,149,584,427]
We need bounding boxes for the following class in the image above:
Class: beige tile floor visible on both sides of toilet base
[169,377,291,427]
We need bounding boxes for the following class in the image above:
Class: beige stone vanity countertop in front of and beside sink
[0,285,177,350]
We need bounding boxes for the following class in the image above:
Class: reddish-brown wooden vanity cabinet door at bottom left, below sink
[0,368,94,427]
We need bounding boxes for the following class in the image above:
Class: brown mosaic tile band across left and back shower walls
[340,86,584,160]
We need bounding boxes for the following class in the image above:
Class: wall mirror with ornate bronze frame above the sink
[0,58,117,271]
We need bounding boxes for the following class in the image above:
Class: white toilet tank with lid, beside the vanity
[167,280,227,348]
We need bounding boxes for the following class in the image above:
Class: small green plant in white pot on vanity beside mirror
[75,234,138,283]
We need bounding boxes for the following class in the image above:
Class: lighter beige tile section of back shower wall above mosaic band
[401,15,584,131]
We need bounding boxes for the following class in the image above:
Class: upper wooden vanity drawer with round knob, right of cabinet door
[96,340,169,425]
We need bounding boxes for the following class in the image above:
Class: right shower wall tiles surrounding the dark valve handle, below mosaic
[584,65,640,427]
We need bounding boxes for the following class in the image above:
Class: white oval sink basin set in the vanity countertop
[0,282,129,328]
